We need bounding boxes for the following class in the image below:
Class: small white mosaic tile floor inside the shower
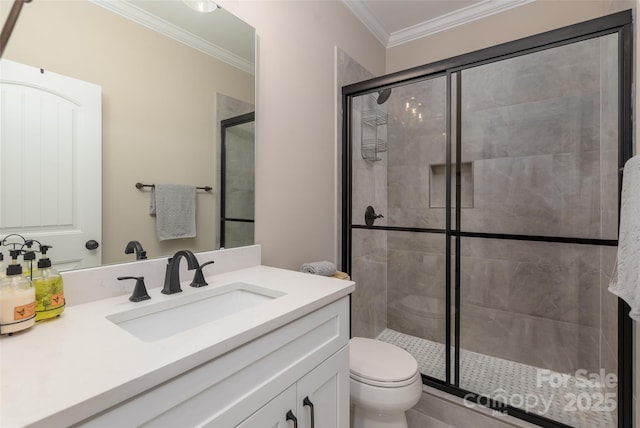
[378,329,617,428]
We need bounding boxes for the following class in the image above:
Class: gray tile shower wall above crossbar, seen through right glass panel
[462,36,617,239]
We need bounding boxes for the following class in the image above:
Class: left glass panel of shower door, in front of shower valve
[351,75,450,381]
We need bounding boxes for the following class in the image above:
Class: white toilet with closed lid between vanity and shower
[349,337,422,428]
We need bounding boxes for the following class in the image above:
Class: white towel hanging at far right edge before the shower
[609,155,640,321]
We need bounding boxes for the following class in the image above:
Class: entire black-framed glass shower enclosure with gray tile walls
[342,11,632,428]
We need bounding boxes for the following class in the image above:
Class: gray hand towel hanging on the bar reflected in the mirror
[149,184,196,241]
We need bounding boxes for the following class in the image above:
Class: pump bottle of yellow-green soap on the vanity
[32,245,65,321]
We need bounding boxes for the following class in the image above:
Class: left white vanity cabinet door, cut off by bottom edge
[237,385,299,428]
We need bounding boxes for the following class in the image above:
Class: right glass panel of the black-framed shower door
[458,34,618,428]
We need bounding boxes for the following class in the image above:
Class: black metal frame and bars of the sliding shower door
[341,10,633,428]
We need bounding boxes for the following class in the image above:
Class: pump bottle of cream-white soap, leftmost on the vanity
[0,248,36,335]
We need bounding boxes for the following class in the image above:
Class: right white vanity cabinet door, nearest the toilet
[296,346,349,428]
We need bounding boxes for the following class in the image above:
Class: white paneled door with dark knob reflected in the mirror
[0,59,102,270]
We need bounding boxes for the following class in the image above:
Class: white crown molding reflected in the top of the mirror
[89,0,255,74]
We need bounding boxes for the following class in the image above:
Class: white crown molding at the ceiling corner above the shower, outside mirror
[342,0,536,48]
